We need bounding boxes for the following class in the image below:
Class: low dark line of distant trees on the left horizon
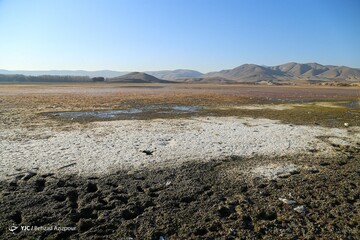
[0,74,96,83]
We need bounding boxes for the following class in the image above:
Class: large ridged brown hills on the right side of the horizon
[203,63,360,82]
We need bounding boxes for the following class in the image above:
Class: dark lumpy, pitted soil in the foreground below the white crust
[0,146,360,239]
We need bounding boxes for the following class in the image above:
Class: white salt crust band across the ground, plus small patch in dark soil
[0,117,360,178]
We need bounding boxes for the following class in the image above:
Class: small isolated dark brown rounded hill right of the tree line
[106,72,171,83]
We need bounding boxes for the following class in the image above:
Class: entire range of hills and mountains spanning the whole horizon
[0,62,360,83]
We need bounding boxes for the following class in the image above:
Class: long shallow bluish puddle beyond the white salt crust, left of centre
[47,105,203,120]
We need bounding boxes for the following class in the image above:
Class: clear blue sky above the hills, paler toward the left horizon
[0,0,360,72]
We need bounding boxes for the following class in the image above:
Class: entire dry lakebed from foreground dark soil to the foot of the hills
[0,84,360,239]
